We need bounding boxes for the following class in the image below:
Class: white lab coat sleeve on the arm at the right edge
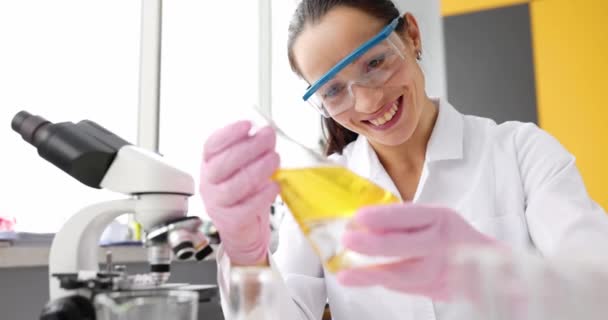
[515,124,608,256]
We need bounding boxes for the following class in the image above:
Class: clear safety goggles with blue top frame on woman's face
[302,18,405,118]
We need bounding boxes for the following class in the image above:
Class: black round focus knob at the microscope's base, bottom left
[40,295,95,320]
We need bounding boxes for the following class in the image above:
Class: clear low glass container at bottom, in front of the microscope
[94,290,198,320]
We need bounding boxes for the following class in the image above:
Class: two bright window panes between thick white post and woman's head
[160,0,320,220]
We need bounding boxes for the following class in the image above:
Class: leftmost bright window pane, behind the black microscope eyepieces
[0,0,140,232]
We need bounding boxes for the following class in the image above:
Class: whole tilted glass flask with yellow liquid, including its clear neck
[251,109,399,273]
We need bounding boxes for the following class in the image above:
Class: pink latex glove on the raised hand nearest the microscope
[200,121,279,265]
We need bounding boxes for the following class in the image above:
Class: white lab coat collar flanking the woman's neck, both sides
[349,99,464,178]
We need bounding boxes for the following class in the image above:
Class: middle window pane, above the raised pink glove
[159,0,263,220]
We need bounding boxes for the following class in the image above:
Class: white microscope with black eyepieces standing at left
[12,111,217,320]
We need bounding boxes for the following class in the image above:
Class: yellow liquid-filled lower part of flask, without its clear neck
[273,166,399,272]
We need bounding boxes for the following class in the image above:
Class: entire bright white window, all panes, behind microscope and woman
[0,0,320,232]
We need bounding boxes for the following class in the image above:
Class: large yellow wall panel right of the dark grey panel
[531,0,608,209]
